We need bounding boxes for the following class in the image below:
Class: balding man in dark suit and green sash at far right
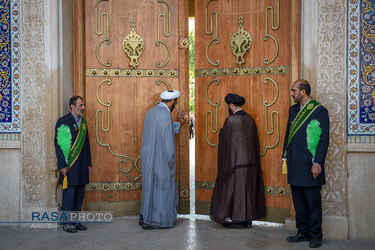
[283,79,329,248]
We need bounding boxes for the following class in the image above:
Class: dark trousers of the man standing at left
[62,185,85,225]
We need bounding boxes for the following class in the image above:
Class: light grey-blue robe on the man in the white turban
[140,103,180,227]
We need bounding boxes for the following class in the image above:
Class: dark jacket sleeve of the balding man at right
[314,107,329,165]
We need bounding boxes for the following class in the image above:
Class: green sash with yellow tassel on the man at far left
[63,117,87,189]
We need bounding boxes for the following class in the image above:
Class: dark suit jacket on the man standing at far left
[55,113,92,185]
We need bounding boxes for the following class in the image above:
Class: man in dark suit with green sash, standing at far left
[55,96,92,233]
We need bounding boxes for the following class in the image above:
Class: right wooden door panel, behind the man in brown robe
[195,0,299,222]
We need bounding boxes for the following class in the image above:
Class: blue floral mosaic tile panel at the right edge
[347,0,375,136]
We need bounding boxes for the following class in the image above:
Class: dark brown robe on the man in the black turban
[210,110,266,223]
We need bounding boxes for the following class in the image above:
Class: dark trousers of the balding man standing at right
[291,186,323,238]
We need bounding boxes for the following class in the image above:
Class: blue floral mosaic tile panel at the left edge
[0,0,21,133]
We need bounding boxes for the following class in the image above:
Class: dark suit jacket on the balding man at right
[283,104,329,187]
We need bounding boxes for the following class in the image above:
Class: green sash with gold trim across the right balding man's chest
[284,98,321,158]
